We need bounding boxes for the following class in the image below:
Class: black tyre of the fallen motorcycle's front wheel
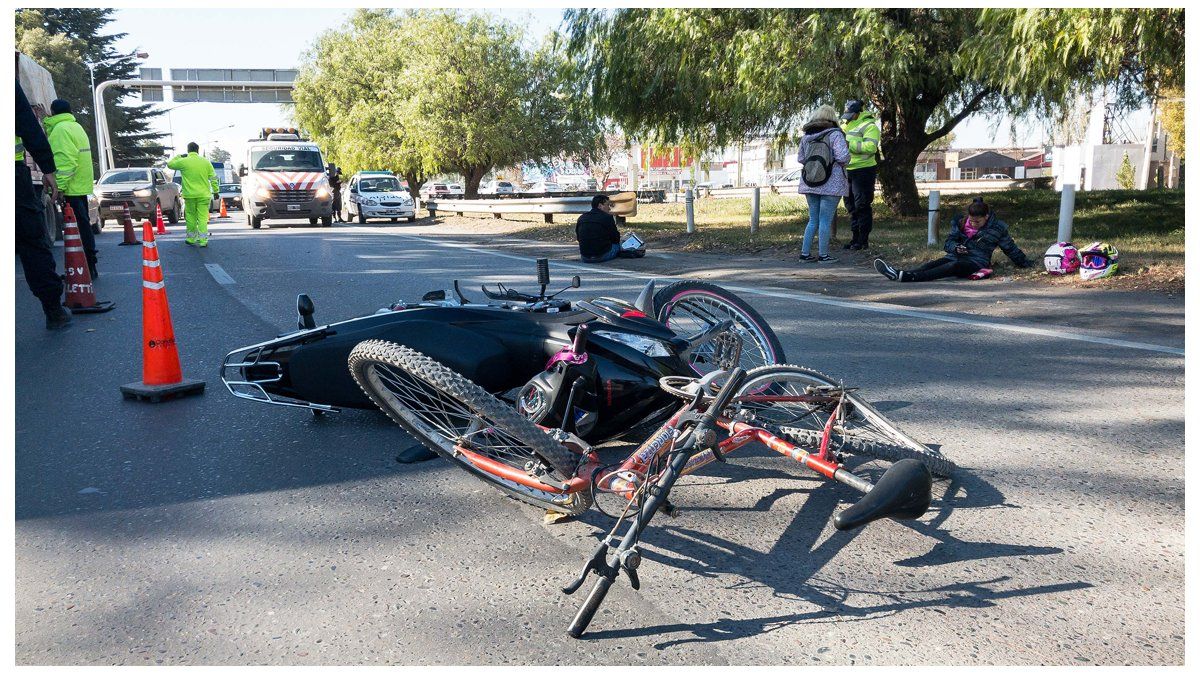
[654,280,787,375]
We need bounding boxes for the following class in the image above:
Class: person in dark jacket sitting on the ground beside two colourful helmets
[875,197,1033,281]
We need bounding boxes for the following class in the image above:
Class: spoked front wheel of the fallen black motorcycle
[654,281,787,375]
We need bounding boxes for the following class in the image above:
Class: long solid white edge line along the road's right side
[347,228,1184,357]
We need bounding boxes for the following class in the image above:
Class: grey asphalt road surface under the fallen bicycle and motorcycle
[16,213,1184,664]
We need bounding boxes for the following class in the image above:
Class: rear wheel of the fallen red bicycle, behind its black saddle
[734,365,955,478]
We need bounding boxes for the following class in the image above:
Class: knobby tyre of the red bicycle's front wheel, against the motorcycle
[348,340,592,515]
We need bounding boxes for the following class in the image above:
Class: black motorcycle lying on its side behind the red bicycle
[221,259,786,442]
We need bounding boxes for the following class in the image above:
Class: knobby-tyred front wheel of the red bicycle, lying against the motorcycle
[348,340,592,515]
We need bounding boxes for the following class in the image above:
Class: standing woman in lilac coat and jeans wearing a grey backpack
[798,106,850,263]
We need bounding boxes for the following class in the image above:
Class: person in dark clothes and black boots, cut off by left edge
[13,80,71,330]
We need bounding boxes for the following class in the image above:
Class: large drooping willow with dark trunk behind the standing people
[564,8,1183,215]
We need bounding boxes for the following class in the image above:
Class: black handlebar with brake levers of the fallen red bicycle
[563,443,691,638]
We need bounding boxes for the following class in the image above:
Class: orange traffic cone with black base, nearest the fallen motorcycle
[121,221,204,404]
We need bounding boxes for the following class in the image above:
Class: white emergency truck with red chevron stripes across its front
[239,127,334,229]
